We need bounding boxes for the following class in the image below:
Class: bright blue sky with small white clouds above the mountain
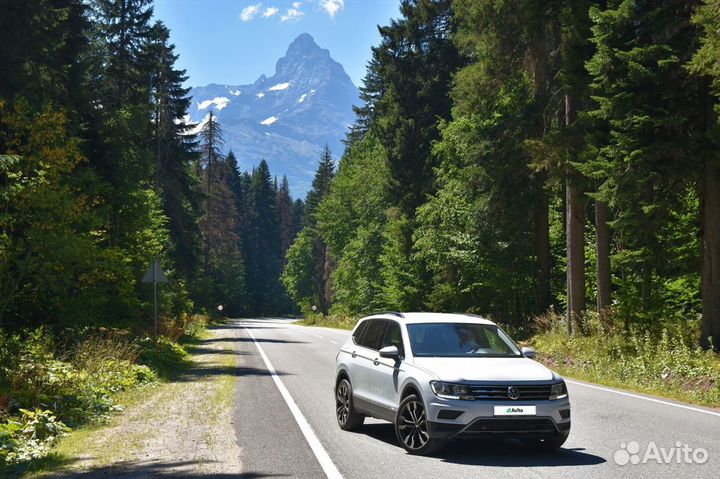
[155,0,399,86]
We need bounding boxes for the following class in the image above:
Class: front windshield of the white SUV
[407,323,522,358]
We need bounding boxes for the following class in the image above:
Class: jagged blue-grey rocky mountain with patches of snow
[189,33,359,197]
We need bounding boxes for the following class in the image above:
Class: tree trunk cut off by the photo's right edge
[700,157,720,351]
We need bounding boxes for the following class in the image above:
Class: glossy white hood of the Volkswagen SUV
[413,358,554,382]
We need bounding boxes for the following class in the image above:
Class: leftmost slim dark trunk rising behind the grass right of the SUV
[534,182,552,312]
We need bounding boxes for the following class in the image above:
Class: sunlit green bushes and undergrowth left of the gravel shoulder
[0,328,170,466]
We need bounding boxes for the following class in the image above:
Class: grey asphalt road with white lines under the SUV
[233,319,720,479]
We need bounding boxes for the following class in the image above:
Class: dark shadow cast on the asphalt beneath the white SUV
[357,424,607,467]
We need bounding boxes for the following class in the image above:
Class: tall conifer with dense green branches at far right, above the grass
[583,0,705,320]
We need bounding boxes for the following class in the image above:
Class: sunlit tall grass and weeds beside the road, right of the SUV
[532,315,720,405]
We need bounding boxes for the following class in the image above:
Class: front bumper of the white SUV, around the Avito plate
[428,398,571,440]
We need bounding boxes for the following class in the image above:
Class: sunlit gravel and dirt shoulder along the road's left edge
[33,326,242,478]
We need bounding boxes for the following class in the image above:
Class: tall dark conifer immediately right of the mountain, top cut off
[358,0,464,217]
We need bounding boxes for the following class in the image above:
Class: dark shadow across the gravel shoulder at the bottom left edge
[33,461,290,479]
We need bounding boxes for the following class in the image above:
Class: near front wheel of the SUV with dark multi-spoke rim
[395,394,445,456]
